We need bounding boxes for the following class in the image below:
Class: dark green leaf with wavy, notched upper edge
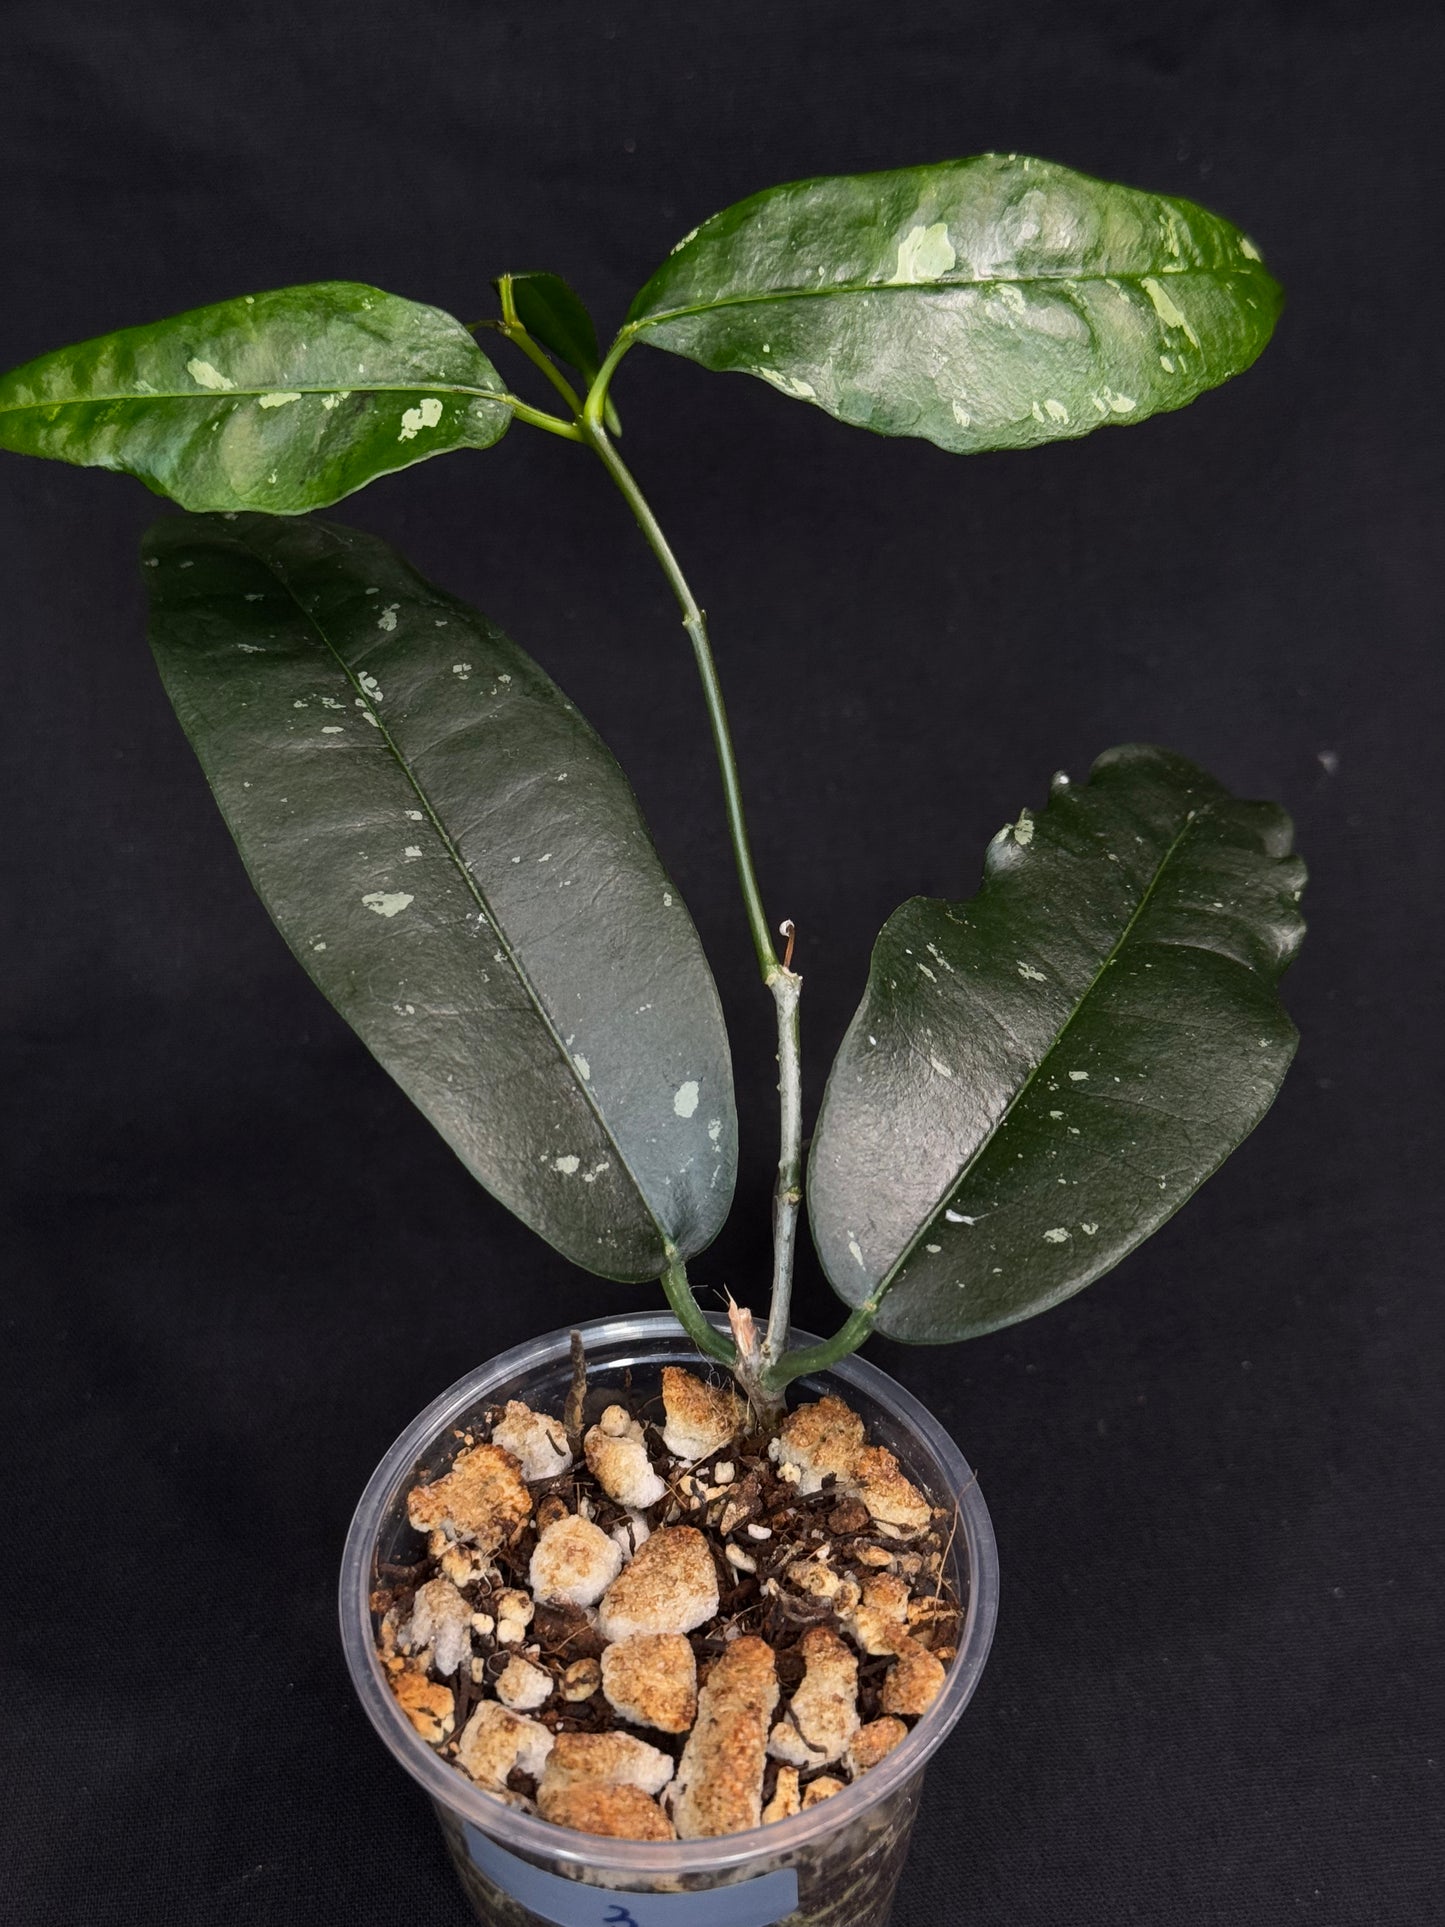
[807,748,1304,1343]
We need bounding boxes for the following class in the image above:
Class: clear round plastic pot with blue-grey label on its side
[341,1312,998,1927]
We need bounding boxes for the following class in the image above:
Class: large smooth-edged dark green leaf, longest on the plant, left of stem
[146,516,736,1280]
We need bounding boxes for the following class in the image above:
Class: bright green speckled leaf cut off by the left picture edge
[0,281,512,515]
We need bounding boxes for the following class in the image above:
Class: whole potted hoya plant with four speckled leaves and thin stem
[0,154,1304,1424]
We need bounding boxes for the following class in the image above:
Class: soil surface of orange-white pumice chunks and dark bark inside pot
[372,1366,961,1838]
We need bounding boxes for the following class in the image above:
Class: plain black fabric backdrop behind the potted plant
[0,0,1445,1927]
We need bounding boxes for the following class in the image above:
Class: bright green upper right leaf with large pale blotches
[626,154,1279,453]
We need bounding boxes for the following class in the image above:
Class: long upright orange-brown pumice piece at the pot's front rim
[672,1634,778,1840]
